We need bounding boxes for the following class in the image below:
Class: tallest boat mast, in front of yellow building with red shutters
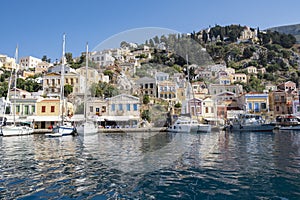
[60,34,66,125]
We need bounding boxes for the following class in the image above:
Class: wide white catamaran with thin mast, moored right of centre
[167,54,211,133]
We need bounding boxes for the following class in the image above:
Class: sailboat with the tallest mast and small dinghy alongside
[46,34,76,137]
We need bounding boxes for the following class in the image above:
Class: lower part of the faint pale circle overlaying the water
[83,132,199,173]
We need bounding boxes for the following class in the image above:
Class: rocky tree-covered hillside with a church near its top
[141,25,300,92]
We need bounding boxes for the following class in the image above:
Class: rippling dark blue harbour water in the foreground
[0,132,300,200]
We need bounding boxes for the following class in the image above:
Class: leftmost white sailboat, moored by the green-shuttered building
[0,47,34,136]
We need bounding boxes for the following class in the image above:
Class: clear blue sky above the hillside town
[0,0,300,61]
